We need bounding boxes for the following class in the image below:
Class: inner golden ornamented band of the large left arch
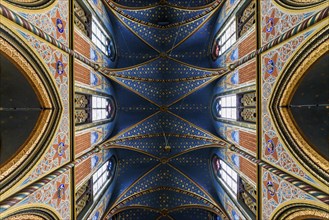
[0,38,53,184]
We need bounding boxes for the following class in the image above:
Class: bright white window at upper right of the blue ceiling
[216,16,236,56]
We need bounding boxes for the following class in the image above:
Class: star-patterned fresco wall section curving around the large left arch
[4,29,70,189]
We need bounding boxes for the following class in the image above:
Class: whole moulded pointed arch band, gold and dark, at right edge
[269,27,329,185]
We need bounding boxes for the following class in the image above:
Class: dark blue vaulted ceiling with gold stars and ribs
[101,0,229,219]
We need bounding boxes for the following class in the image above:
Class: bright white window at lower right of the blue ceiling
[218,159,238,199]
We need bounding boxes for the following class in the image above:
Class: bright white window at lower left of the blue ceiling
[92,161,110,201]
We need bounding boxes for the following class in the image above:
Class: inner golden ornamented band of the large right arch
[279,40,329,172]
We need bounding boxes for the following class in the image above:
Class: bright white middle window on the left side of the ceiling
[91,96,110,122]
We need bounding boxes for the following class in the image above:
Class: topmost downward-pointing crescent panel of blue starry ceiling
[114,12,210,51]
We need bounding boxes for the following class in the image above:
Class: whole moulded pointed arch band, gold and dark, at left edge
[0,28,62,192]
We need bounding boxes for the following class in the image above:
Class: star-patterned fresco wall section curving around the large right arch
[262,29,317,184]
